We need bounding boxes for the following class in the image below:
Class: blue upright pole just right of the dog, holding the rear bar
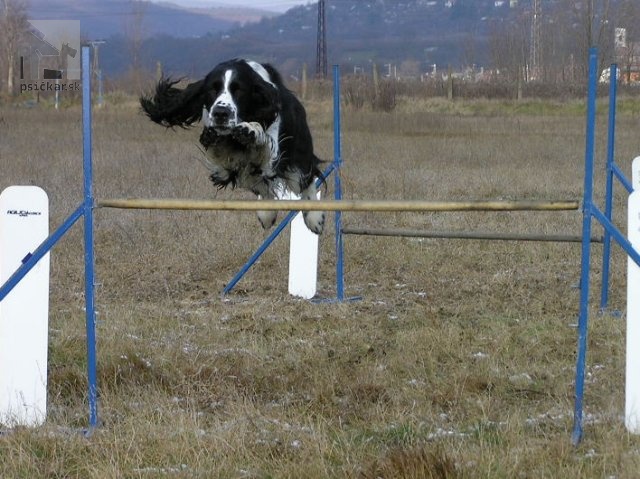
[333,65,344,301]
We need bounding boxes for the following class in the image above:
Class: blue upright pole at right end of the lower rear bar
[600,63,618,310]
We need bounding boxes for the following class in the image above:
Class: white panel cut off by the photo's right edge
[624,157,640,434]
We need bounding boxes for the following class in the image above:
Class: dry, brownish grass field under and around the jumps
[0,93,640,479]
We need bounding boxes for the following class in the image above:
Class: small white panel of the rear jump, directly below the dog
[279,191,320,299]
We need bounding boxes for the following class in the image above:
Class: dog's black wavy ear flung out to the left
[140,78,206,128]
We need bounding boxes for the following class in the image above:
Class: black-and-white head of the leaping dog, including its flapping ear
[140,59,281,134]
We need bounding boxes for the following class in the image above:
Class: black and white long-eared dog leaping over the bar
[140,59,324,234]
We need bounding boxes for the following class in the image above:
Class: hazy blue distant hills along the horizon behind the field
[61,0,631,82]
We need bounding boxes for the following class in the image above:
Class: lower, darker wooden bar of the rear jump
[342,228,603,243]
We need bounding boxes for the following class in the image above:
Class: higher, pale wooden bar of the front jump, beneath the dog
[96,198,580,212]
